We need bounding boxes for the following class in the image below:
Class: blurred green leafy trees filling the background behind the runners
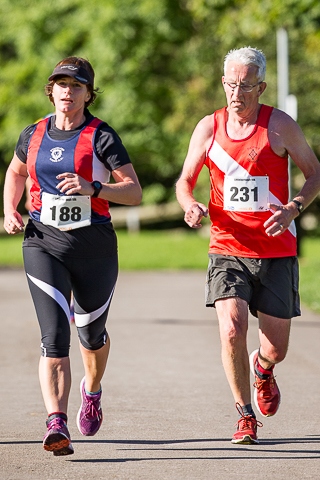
[0,0,320,231]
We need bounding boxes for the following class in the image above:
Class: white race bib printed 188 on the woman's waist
[40,192,91,230]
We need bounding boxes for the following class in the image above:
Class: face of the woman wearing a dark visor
[52,77,91,113]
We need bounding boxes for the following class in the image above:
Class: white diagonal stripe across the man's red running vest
[209,140,297,237]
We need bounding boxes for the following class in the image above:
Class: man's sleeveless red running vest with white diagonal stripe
[205,105,297,258]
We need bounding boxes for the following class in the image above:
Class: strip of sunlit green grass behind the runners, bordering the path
[0,230,320,313]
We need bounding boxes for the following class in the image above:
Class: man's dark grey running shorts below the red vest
[206,254,301,319]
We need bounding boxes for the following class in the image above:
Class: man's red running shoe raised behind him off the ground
[249,350,281,417]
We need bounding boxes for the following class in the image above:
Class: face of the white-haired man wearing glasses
[222,61,267,117]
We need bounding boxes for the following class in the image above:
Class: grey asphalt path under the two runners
[0,270,320,480]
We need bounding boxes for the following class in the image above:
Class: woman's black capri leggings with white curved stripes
[23,223,118,358]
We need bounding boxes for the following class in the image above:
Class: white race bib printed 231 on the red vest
[223,176,269,212]
